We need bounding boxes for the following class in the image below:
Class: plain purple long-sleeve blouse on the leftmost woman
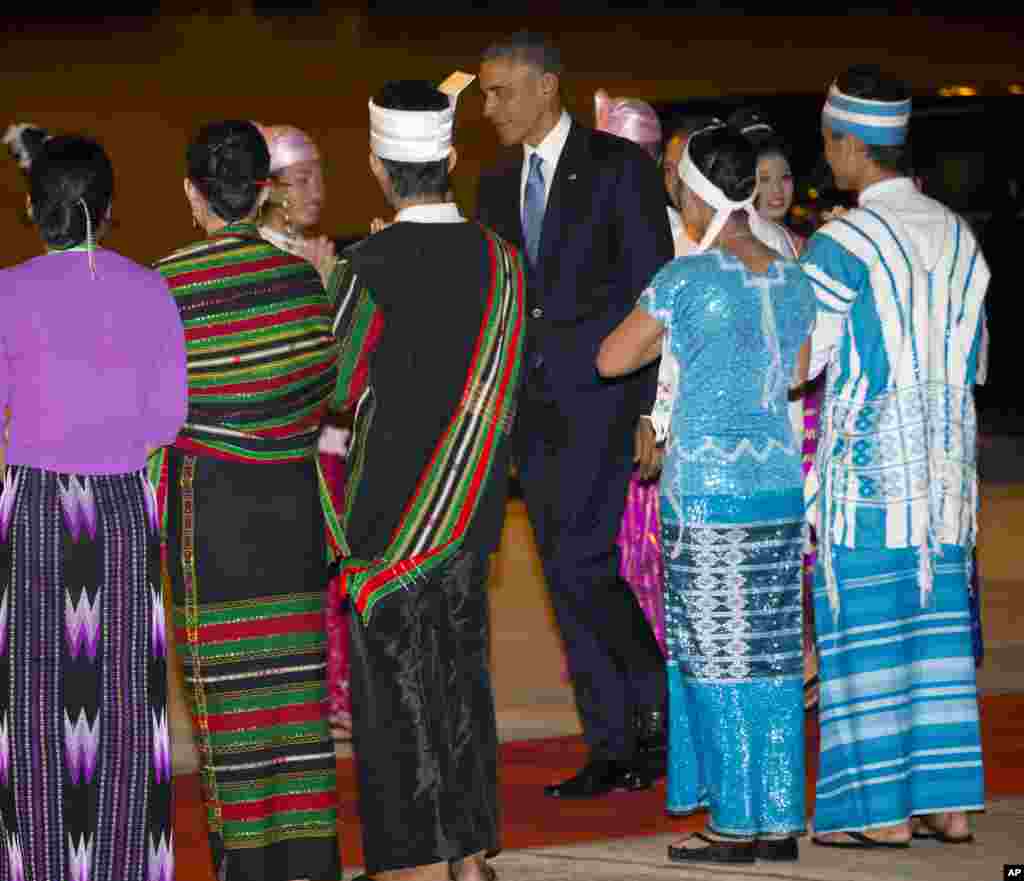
[0,248,187,474]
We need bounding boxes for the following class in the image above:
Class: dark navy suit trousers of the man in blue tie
[516,364,667,759]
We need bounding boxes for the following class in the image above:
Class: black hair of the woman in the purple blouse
[29,134,114,248]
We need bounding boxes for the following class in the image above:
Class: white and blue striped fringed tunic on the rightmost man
[801,177,989,614]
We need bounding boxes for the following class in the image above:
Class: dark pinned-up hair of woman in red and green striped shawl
[185,120,270,223]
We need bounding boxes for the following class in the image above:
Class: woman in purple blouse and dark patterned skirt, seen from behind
[0,130,186,881]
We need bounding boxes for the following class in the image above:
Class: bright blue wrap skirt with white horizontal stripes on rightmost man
[814,545,984,832]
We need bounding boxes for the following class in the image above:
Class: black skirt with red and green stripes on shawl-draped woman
[167,450,341,881]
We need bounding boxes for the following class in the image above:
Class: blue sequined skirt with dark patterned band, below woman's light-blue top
[662,499,806,836]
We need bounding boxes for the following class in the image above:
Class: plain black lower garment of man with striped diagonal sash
[349,549,499,875]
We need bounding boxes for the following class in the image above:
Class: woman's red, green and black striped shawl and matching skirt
[153,224,341,881]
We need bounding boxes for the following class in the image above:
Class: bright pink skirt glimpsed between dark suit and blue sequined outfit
[615,473,666,653]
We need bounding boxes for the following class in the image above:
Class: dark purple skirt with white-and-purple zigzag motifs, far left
[0,465,174,881]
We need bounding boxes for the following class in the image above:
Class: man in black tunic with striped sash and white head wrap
[333,81,524,881]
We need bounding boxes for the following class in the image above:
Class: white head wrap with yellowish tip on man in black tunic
[370,72,476,163]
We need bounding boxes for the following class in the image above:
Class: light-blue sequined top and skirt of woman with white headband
[639,250,814,836]
